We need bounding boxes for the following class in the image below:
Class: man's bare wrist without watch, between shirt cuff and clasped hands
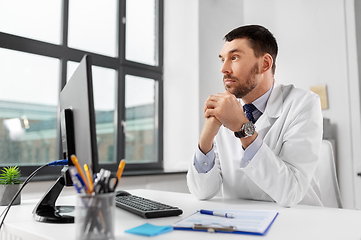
[199,117,222,154]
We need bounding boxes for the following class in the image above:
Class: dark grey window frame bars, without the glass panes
[0,0,164,180]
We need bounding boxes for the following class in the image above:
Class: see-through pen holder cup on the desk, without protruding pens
[75,192,115,240]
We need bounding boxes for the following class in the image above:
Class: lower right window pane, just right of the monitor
[125,75,158,163]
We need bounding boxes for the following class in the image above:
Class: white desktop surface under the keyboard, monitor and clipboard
[0,190,361,240]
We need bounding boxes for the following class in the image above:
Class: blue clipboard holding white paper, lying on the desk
[172,210,278,235]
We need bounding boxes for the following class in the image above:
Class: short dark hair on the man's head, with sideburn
[224,25,278,75]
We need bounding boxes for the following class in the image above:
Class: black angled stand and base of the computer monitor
[33,169,74,223]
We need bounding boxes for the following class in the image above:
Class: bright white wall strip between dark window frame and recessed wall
[164,0,199,171]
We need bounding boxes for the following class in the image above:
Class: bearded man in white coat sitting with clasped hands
[187,25,323,207]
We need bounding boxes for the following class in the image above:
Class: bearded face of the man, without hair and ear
[219,38,259,98]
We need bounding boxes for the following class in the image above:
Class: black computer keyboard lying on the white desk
[115,191,183,218]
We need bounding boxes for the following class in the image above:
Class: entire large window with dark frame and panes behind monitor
[0,0,163,177]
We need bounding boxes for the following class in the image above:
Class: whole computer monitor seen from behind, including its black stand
[33,55,99,223]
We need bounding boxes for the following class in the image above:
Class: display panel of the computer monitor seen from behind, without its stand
[60,55,99,176]
